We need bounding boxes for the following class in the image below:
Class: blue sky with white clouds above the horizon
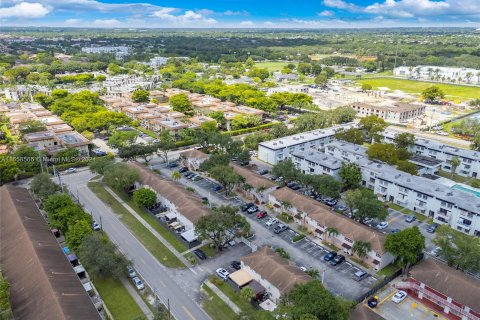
[0,0,480,29]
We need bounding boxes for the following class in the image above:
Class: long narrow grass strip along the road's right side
[88,182,185,268]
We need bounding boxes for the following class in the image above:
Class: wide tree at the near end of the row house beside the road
[195,206,250,250]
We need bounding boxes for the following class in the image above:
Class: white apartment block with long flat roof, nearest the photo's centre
[258,123,355,165]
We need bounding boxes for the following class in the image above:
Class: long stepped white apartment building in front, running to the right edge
[325,141,480,236]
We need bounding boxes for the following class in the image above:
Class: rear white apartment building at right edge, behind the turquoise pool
[383,131,480,178]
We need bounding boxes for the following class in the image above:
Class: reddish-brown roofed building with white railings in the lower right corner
[395,258,480,320]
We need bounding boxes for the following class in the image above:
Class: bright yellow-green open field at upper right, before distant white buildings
[357,78,480,100]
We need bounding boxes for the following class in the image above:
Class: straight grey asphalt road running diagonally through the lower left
[62,170,210,320]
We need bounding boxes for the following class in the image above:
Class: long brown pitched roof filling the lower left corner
[0,185,101,320]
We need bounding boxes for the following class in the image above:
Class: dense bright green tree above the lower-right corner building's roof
[385,226,425,275]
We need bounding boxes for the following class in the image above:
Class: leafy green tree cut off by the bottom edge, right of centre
[277,280,350,320]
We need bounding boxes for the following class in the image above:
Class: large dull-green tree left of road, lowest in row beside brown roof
[78,233,130,279]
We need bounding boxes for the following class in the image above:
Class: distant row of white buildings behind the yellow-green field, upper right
[393,66,480,84]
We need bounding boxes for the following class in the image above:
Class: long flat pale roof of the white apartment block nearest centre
[259,123,354,150]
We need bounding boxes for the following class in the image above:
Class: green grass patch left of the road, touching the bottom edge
[93,278,144,320]
